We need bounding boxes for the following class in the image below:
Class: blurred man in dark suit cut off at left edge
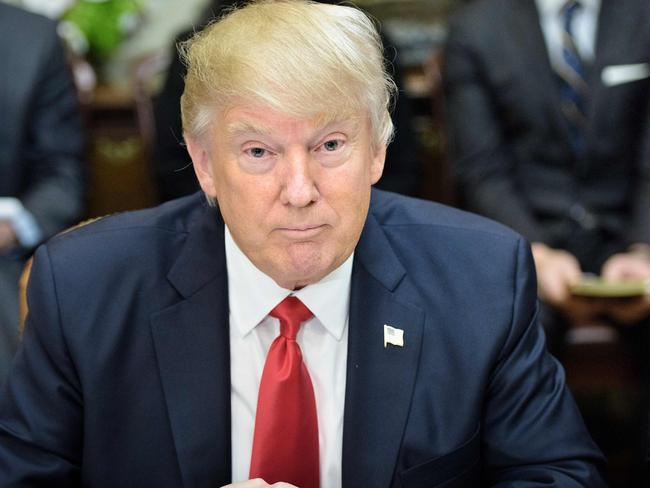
[0,3,83,383]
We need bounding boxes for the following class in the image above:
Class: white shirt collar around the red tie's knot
[225,226,354,340]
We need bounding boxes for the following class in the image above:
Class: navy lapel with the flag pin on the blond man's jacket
[343,214,424,487]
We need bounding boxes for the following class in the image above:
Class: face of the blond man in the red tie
[187,105,385,289]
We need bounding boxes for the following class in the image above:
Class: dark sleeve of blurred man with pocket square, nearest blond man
[443,16,548,242]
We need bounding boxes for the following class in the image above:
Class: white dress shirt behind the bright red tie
[225,227,354,488]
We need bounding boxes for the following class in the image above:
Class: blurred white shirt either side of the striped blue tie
[535,0,600,65]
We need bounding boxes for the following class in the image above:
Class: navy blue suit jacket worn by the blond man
[0,191,604,488]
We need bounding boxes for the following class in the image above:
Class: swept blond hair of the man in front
[179,0,396,147]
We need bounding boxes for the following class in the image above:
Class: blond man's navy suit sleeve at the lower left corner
[0,247,83,488]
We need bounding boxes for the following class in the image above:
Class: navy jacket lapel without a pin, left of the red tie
[151,210,231,487]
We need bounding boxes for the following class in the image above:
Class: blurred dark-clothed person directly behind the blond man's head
[152,0,423,201]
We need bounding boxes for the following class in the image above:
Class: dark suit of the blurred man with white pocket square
[444,0,650,480]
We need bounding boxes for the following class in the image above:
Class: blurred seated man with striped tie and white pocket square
[444,0,650,482]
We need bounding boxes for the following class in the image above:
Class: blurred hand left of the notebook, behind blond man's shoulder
[532,242,582,310]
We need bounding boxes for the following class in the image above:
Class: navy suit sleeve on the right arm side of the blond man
[483,236,606,488]
